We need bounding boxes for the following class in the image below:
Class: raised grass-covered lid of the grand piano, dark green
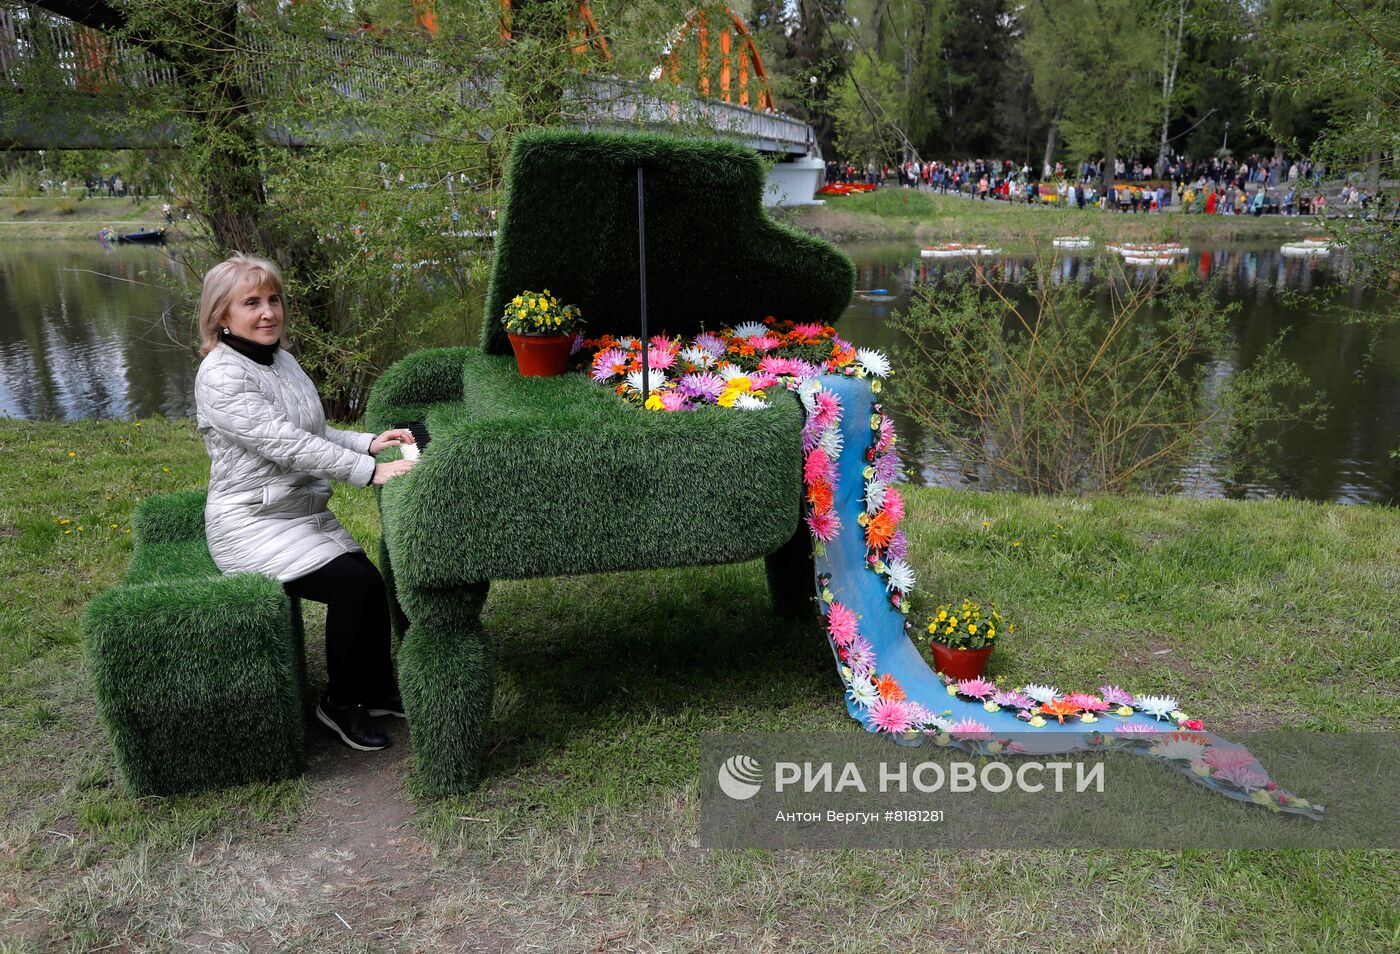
[482,130,855,354]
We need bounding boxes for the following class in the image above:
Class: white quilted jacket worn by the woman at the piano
[195,345,374,583]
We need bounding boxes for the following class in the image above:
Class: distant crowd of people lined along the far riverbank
[826,154,1396,216]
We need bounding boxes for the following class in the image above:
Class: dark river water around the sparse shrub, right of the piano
[840,244,1400,503]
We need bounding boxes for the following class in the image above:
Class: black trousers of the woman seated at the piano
[281,553,395,705]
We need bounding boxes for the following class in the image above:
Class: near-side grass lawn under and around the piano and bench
[0,419,1400,951]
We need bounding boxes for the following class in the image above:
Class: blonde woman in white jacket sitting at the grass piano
[195,254,413,751]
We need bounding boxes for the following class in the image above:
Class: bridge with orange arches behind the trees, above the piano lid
[0,0,822,203]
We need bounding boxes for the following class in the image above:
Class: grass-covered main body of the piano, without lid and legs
[381,352,802,588]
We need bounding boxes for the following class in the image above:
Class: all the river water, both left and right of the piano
[0,241,1400,503]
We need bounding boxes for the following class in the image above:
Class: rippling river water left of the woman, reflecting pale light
[0,242,195,420]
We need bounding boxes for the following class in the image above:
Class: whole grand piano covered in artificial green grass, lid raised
[365,132,855,796]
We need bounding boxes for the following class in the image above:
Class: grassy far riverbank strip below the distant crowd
[780,188,1317,242]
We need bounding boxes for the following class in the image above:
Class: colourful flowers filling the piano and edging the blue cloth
[584,317,1322,817]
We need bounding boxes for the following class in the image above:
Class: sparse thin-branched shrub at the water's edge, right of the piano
[895,249,1326,493]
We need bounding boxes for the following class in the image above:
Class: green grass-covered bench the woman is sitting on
[83,492,305,794]
